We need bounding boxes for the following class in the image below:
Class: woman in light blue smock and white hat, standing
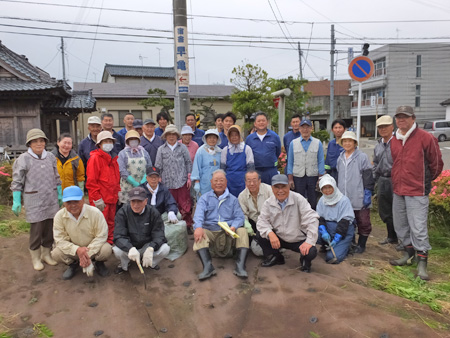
[191,129,222,195]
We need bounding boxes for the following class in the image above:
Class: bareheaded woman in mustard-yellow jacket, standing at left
[52,133,85,191]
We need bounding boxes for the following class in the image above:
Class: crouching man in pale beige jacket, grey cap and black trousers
[256,175,319,272]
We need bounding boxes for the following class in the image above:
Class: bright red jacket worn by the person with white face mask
[86,149,120,205]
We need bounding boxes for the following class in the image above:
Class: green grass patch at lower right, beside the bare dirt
[369,266,450,312]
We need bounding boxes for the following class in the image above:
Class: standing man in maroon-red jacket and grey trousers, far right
[390,106,444,280]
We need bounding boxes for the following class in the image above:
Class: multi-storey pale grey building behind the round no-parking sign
[351,43,450,136]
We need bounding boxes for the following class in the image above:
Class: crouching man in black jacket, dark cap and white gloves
[113,187,170,274]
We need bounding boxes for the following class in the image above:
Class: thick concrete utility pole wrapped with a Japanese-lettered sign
[173,0,190,129]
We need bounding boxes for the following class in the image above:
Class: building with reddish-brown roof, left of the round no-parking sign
[305,80,353,129]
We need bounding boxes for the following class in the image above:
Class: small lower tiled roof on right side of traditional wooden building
[44,90,97,112]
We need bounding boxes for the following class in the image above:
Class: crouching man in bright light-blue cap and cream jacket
[52,186,112,280]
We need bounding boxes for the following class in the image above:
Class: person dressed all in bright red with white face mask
[86,130,120,244]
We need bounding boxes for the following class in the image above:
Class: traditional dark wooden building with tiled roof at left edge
[0,41,96,154]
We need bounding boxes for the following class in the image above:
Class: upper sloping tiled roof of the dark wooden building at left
[0,41,53,82]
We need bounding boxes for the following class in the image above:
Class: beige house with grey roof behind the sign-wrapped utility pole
[73,64,234,138]
